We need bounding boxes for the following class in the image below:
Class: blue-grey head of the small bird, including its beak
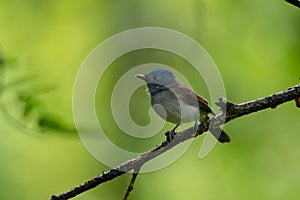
[136,68,178,86]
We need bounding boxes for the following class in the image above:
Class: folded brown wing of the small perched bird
[170,84,213,113]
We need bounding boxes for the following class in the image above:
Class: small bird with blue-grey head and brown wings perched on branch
[135,68,230,143]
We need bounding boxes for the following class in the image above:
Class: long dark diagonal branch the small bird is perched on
[51,84,300,200]
